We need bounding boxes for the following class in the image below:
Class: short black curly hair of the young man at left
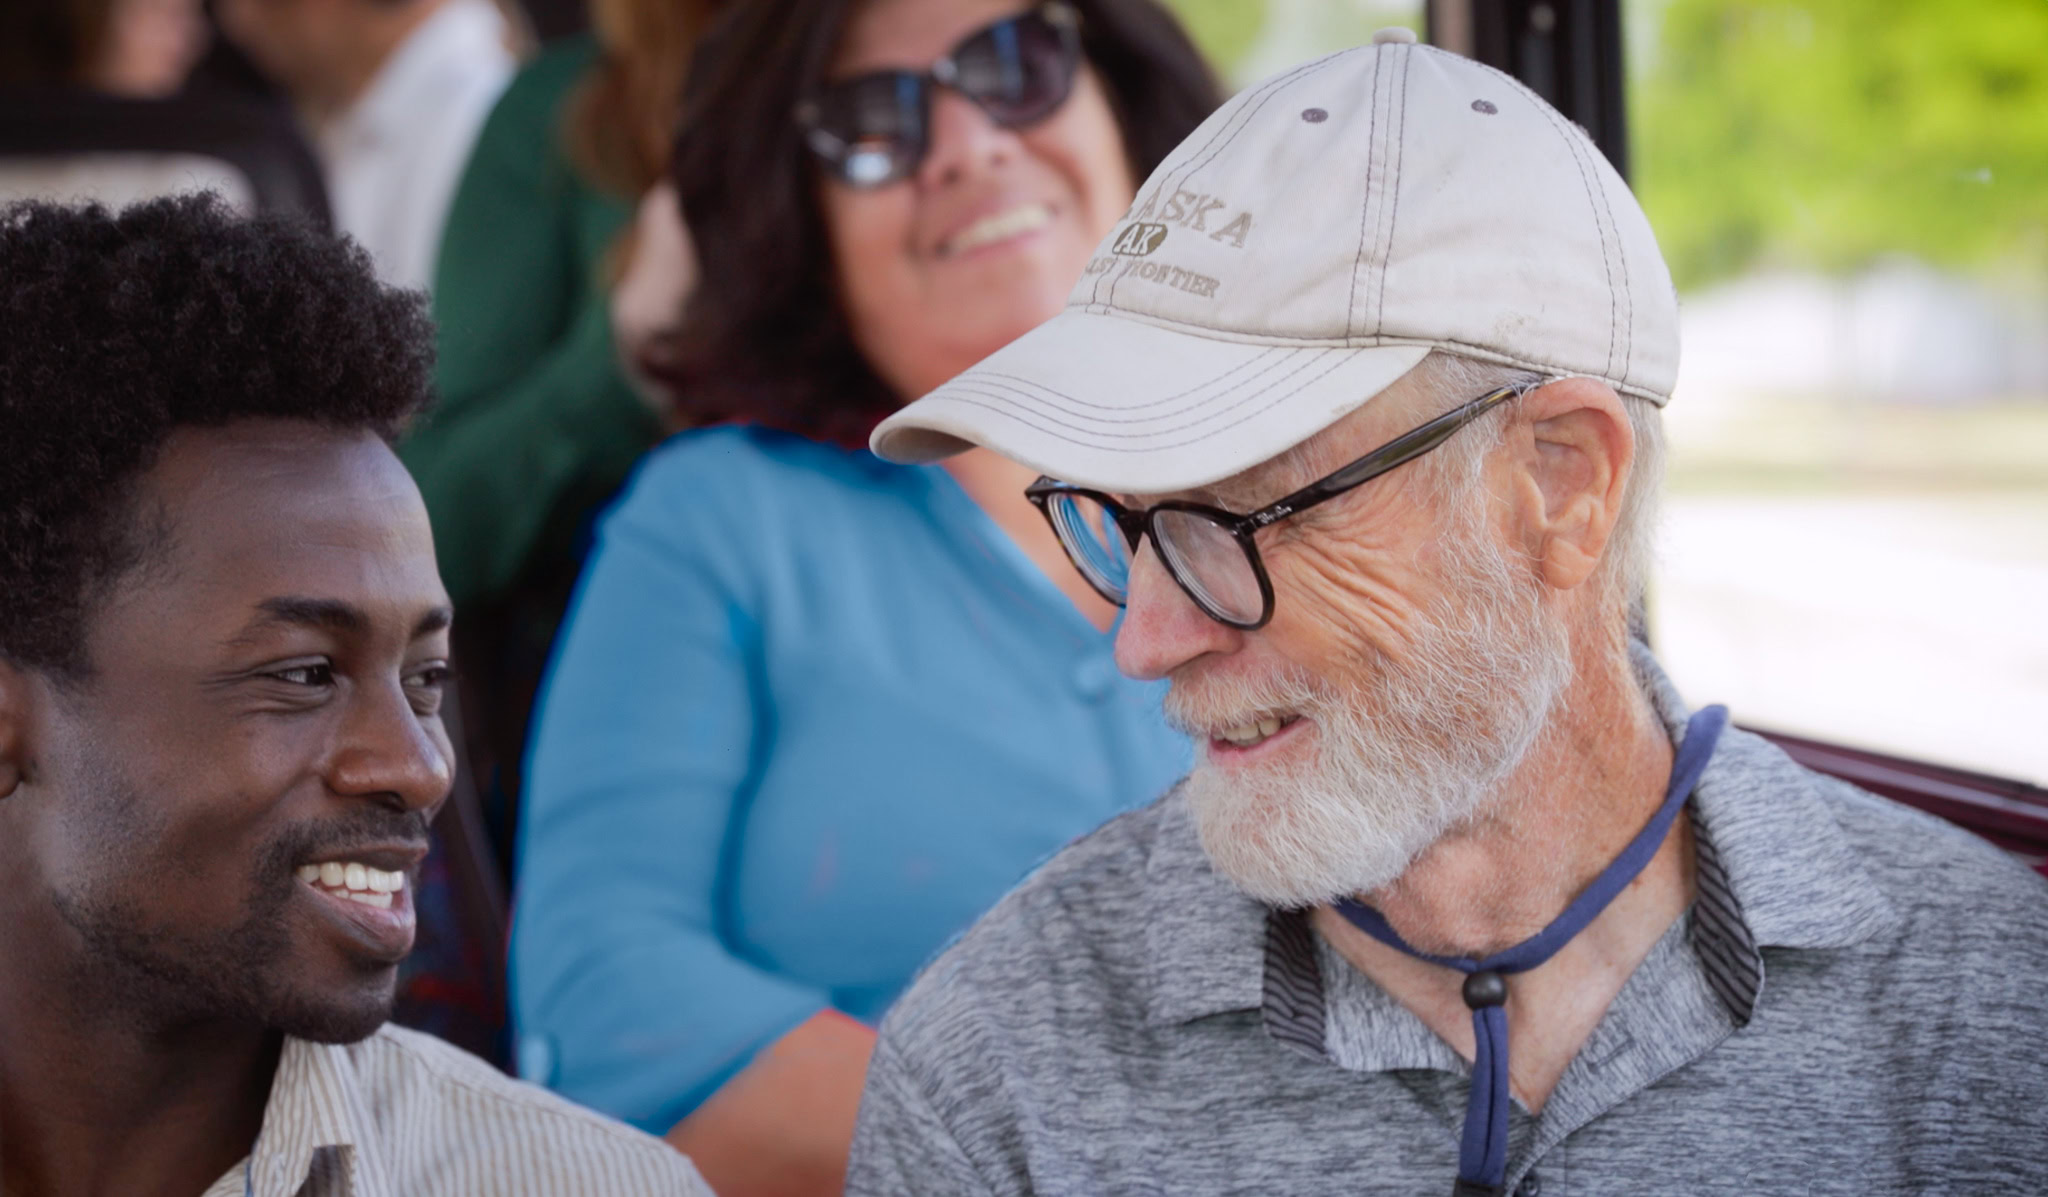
[0,195,432,676]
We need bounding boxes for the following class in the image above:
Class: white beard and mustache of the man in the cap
[1167,510,1573,908]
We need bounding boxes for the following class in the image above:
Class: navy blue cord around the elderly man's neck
[1337,707,1729,1197]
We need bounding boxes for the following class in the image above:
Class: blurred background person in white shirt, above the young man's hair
[217,0,514,287]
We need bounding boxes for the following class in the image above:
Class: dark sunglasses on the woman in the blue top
[797,0,1081,187]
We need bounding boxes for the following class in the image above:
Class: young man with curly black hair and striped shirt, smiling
[0,199,707,1197]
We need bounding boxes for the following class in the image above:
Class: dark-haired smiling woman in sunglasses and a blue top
[512,0,1217,1197]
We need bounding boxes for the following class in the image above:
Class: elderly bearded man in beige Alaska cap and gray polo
[850,31,2048,1197]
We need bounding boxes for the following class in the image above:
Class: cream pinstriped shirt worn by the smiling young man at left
[205,1027,711,1197]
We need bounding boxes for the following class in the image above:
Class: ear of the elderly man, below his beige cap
[1513,377,1636,590]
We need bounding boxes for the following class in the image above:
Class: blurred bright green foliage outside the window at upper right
[1624,0,2048,289]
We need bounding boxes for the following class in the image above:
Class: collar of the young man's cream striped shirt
[250,1037,397,1197]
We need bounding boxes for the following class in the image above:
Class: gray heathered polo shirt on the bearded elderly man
[848,658,2048,1197]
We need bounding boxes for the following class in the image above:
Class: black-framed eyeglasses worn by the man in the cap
[1024,387,1518,631]
